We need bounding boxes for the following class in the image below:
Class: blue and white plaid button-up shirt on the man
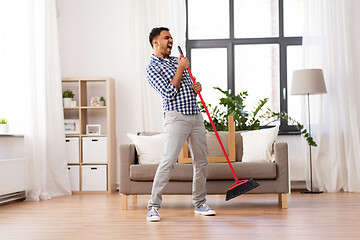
[146,55,200,115]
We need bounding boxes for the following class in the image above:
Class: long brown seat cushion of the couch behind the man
[130,162,276,181]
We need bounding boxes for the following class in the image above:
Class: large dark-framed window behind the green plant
[186,0,303,134]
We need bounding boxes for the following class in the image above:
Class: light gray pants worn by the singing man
[148,111,208,209]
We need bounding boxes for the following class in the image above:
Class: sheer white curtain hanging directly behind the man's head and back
[127,0,186,131]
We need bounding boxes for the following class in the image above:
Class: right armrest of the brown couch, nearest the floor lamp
[274,142,290,193]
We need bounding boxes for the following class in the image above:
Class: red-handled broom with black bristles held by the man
[178,46,259,201]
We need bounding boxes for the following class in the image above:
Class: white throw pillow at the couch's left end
[127,133,165,164]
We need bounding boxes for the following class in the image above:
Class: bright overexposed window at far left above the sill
[0,1,26,134]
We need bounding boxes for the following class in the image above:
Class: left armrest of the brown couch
[119,144,136,194]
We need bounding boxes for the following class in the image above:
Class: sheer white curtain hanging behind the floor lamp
[303,0,360,192]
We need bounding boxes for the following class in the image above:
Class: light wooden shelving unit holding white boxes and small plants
[62,77,116,193]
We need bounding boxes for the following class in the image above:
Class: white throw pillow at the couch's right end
[241,126,279,162]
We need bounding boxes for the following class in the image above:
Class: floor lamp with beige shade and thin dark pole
[291,69,326,193]
